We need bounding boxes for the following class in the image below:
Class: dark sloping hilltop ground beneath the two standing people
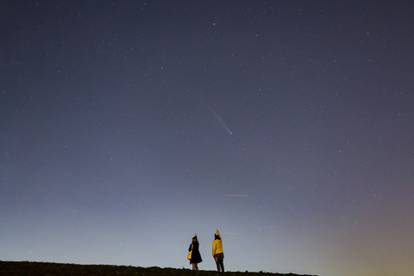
[0,261,316,276]
